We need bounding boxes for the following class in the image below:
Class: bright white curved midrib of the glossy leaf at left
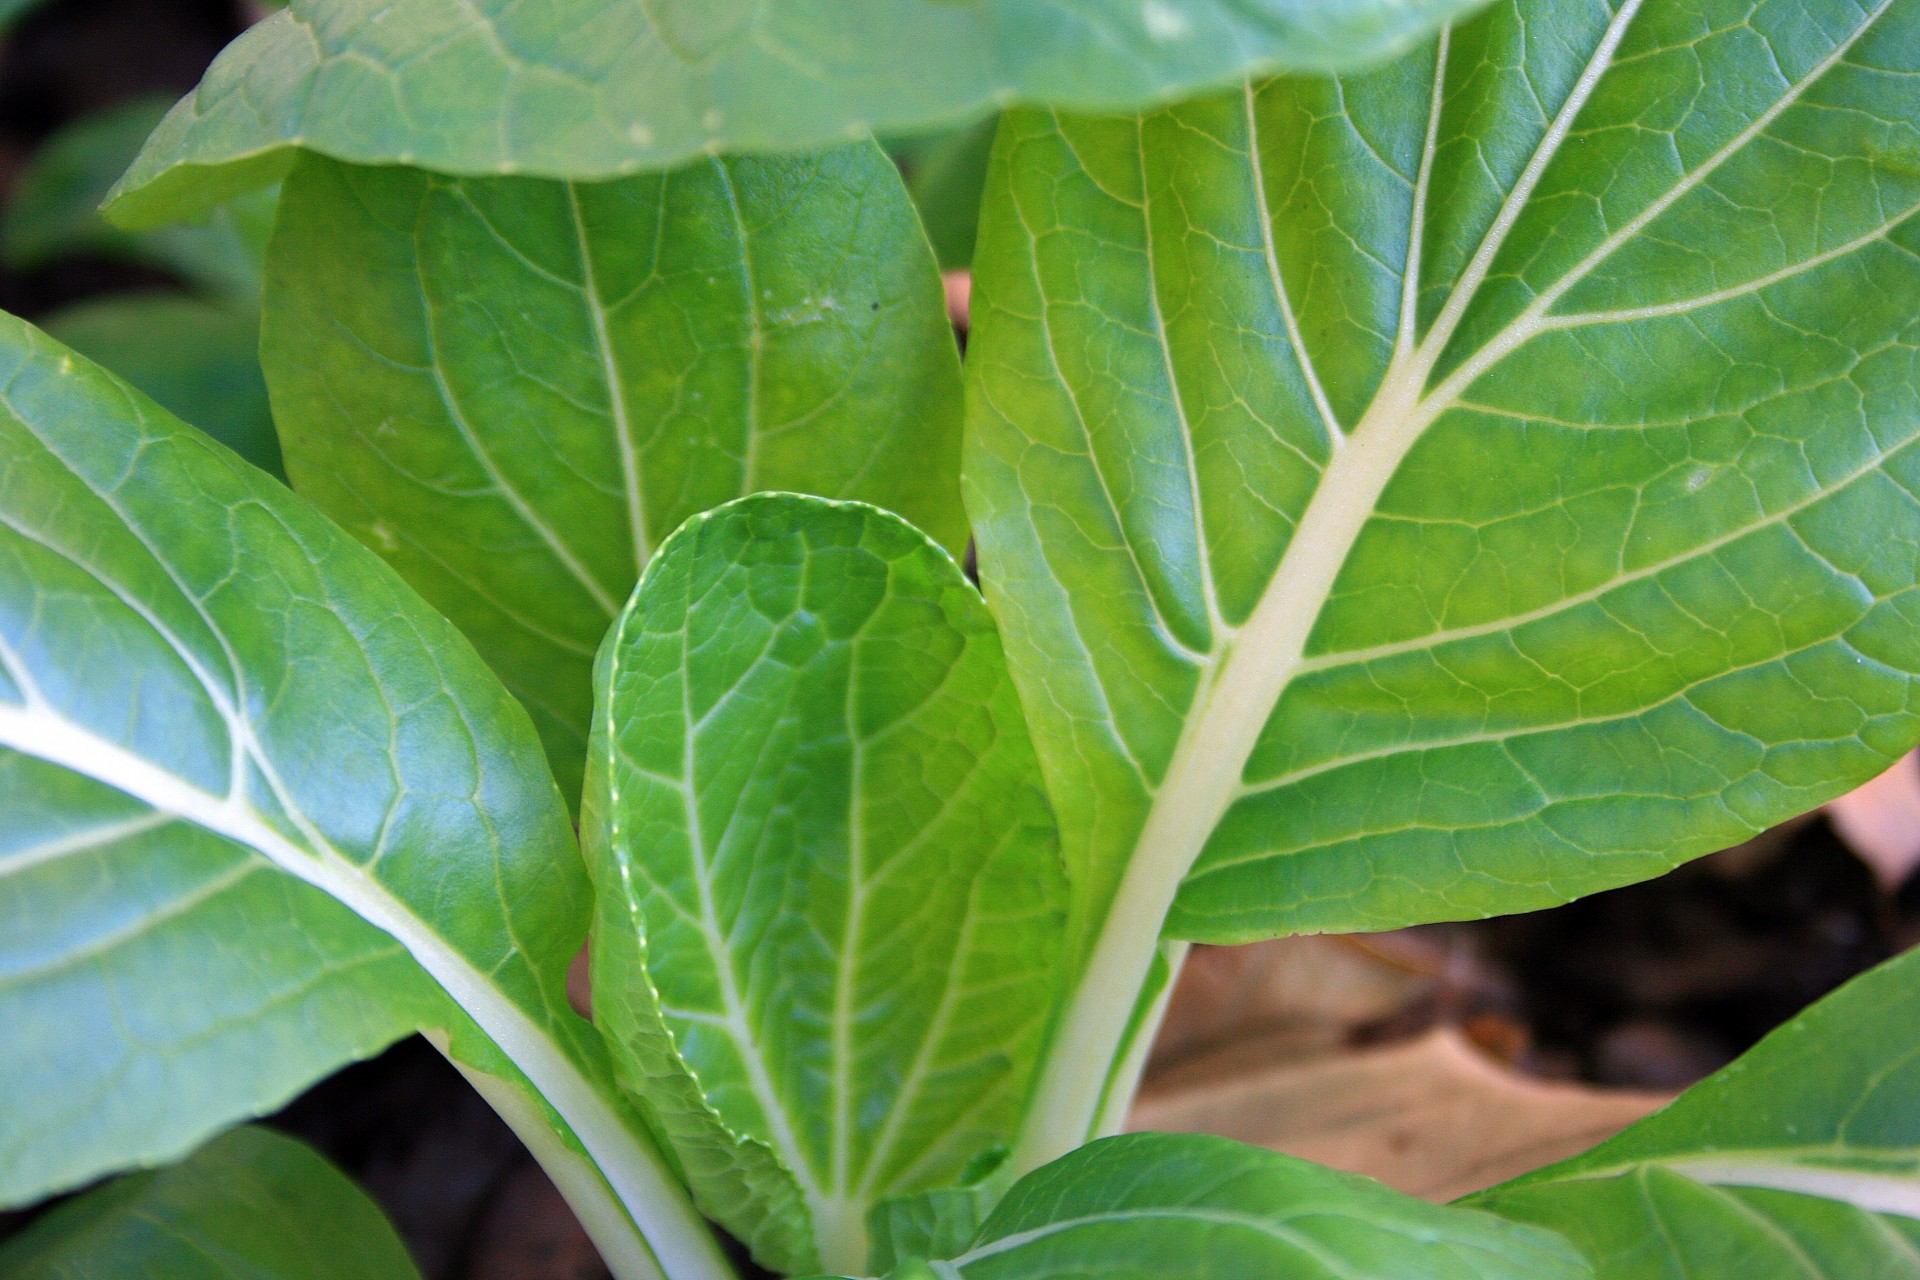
[0,679,733,1280]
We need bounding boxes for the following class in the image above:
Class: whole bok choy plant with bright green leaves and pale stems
[0,0,1920,1280]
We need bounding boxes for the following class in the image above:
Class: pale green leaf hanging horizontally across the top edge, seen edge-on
[97,0,1476,223]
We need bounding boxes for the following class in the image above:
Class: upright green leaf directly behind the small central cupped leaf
[263,142,966,796]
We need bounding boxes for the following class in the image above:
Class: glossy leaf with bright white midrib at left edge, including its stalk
[0,317,726,1276]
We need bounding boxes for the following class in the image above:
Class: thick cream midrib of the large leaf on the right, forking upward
[1008,0,1893,1176]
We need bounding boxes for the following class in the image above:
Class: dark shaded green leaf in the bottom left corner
[0,1128,420,1280]
